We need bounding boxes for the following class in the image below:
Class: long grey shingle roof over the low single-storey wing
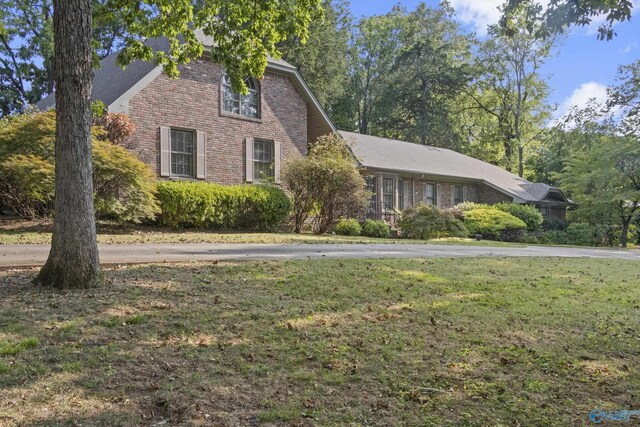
[340,131,568,202]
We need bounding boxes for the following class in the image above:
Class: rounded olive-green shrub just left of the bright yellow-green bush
[398,204,467,240]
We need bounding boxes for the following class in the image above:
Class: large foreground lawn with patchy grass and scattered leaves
[0,258,640,426]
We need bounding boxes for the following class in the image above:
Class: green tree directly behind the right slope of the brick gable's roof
[278,0,352,111]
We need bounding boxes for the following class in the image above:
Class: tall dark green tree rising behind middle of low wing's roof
[379,1,472,149]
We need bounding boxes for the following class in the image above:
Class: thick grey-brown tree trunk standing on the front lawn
[35,0,102,288]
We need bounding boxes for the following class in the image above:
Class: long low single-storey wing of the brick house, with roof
[340,131,571,222]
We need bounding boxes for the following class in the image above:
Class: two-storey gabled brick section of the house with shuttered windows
[37,32,336,184]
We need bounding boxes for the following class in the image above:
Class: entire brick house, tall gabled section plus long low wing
[37,32,570,221]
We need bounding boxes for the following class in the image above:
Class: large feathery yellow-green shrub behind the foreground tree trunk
[0,112,158,222]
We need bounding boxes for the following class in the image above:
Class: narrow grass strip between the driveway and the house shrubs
[0,218,522,246]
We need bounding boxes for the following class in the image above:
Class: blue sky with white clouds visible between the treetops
[351,0,640,116]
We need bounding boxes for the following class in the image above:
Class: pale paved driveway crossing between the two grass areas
[0,243,640,268]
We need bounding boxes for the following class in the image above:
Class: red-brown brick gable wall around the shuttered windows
[129,59,307,184]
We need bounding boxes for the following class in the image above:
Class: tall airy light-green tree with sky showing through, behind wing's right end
[468,0,553,176]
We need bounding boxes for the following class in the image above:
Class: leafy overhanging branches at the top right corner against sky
[500,0,633,40]
